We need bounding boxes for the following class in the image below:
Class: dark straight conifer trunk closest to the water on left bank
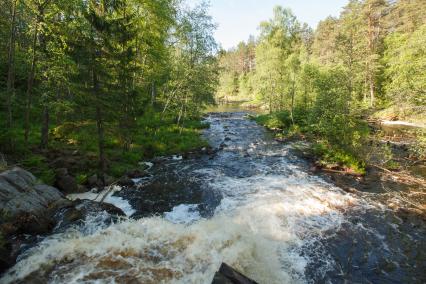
[92,69,106,185]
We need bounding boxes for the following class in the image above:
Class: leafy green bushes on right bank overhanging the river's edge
[255,65,369,174]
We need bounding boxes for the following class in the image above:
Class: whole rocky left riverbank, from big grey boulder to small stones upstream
[0,143,214,274]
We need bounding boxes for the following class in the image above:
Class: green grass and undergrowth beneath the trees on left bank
[0,111,209,184]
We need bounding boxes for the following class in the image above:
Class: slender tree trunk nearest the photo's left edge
[6,0,17,150]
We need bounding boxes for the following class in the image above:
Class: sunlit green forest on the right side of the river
[217,0,426,171]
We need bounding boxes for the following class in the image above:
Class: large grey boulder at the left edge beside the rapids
[0,167,65,273]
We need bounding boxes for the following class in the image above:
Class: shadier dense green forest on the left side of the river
[0,0,218,182]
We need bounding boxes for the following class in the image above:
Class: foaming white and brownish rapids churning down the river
[1,112,404,284]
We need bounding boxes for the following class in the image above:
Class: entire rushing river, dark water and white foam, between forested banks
[0,112,426,284]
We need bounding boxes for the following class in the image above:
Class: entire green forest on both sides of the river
[0,0,426,182]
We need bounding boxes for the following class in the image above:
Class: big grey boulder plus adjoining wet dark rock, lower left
[0,167,124,273]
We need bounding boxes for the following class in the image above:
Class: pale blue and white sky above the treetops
[187,0,348,49]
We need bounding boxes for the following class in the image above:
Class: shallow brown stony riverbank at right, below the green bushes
[286,141,426,225]
